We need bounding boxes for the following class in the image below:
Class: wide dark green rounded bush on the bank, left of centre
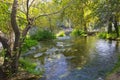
[30,30,56,41]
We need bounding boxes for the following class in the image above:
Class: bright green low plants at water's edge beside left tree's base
[19,58,43,75]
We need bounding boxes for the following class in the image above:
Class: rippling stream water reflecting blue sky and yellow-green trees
[24,37,120,80]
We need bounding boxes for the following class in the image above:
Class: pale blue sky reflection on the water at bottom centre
[45,54,69,80]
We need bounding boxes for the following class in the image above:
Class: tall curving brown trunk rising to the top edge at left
[11,0,20,73]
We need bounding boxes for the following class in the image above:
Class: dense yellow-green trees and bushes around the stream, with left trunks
[0,0,120,78]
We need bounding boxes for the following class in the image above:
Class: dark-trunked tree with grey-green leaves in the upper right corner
[93,0,120,37]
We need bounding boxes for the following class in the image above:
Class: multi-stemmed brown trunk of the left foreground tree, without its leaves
[0,0,31,77]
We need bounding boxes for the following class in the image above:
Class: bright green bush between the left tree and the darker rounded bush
[22,38,38,52]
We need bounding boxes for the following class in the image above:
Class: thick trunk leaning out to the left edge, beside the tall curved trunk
[0,35,11,78]
